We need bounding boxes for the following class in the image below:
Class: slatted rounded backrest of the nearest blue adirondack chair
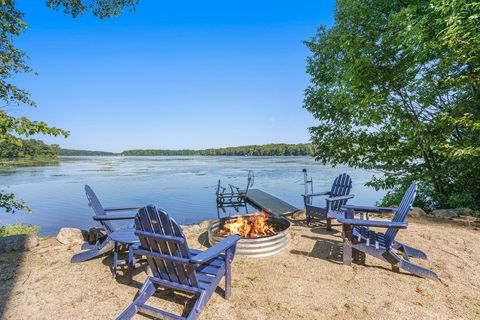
[135,206,198,287]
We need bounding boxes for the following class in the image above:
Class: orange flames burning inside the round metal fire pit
[218,212,275,238]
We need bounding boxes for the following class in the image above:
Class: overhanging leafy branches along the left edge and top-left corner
[0,0,138,212]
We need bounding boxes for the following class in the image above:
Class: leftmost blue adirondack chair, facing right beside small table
[71,185,139,269]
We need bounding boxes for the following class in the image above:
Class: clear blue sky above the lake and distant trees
[15,0,334,151]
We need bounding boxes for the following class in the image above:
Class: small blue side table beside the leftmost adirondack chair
[109,228,140,282]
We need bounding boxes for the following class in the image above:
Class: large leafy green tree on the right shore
[304,0,480,209]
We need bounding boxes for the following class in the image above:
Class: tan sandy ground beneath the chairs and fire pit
[0,211,480,320]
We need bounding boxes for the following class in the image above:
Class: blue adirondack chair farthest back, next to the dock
[303,173,354,230]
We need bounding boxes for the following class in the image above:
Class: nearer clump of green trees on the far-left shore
[0,139,60,159]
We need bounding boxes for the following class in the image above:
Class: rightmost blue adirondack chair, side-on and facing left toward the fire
[337,182,438,279]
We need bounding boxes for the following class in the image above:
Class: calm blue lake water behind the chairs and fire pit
[0,156,385,235]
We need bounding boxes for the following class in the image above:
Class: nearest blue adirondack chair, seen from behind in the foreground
[117,206,240,320]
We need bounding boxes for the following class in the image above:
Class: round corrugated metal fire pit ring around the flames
[208,214,291,258]
